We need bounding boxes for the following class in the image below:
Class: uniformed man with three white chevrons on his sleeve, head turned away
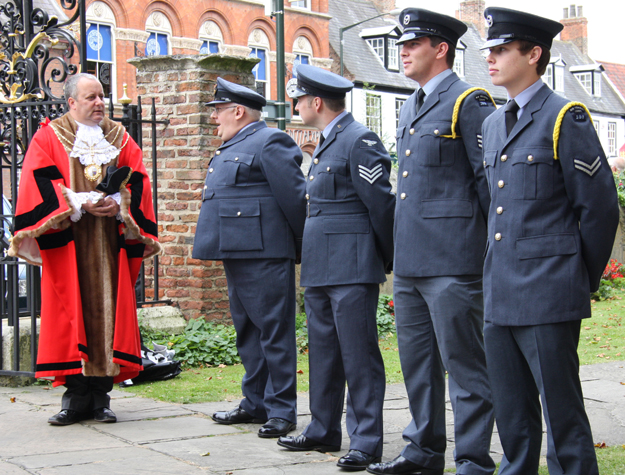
[278,65,395,470]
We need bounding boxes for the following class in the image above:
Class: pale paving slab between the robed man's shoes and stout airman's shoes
[91,415,243,444]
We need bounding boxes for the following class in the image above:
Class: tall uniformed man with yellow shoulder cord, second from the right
[369,8,495,475]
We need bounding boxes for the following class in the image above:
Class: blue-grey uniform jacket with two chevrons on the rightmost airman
[483,85,619,326]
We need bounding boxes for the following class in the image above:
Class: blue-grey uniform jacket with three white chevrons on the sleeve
[301,114,395,287]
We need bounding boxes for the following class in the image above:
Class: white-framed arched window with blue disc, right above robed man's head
[87,2,116,98]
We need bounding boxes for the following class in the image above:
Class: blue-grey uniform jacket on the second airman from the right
[394,74,495,277]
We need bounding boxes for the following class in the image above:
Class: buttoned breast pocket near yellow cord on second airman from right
[418,122,463,167]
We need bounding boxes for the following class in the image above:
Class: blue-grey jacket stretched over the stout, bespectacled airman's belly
[193,122,306,260]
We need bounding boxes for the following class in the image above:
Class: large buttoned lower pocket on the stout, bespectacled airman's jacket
[219,200,263,251]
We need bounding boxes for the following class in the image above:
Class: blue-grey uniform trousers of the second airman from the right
[393,275,495,475]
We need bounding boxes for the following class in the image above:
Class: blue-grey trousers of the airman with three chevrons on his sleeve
[303,284,386,457]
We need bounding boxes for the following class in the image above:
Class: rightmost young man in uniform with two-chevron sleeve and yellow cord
[483,8,619,475]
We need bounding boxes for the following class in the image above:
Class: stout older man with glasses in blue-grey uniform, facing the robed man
[193,78,306,437]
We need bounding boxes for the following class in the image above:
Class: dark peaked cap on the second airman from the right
[397,8,467,45]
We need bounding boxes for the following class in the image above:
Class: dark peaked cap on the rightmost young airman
[482,7,564,49]
